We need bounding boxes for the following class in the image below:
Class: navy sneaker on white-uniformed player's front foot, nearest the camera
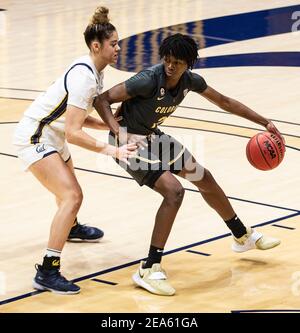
[32,264,80,295]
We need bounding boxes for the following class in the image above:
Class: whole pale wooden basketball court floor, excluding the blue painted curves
[0,0,300,313]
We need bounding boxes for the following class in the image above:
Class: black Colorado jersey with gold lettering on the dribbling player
[120,64,207,135]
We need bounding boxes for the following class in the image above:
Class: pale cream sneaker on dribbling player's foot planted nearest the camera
[132,261,175,296]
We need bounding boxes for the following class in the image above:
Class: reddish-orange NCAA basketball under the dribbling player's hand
[246,132,285,170]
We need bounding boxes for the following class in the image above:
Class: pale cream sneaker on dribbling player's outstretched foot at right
[231,228,280,252]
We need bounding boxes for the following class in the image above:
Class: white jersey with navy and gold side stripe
[13,55,103,147]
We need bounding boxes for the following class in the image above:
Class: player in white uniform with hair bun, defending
[14,7,136,294]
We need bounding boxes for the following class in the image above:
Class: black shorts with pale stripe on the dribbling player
[109,132,192,188]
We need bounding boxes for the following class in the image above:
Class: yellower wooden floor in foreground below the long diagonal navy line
[1,215,300,313]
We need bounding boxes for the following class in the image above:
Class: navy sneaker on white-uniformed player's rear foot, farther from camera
[68,223,104,242]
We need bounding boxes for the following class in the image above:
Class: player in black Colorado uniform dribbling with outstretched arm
[94,34,283,295]
